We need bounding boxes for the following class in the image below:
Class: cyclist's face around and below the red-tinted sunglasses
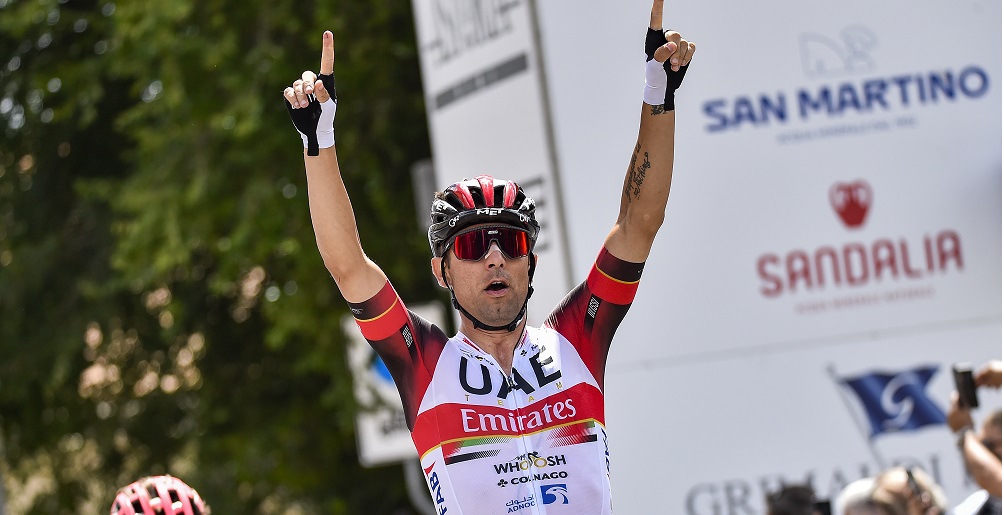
[432,224,530,325]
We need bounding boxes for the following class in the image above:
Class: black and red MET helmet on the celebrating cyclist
[429,176,540,257]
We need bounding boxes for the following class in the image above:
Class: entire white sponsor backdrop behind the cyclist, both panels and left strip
[405,0,1001,515]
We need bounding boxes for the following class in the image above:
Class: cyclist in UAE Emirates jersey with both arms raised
[283,0,695,514]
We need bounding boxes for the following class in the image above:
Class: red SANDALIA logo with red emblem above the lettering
[756,181,964,298]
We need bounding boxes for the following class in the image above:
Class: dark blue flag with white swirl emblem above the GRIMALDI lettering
[841,366,945,438]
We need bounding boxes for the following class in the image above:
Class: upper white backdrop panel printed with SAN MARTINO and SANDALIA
[537,0,1001,355]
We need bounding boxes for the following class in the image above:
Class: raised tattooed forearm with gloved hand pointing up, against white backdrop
[604,0,695,263]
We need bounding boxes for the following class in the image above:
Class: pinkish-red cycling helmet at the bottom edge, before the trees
[111,476,209,515]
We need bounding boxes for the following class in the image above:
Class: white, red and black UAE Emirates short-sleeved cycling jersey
[351,249,643,515]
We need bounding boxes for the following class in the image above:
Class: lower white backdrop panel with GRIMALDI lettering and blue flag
[606,326,1001,515]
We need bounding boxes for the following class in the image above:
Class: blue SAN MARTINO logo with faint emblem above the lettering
[703,26,991,133]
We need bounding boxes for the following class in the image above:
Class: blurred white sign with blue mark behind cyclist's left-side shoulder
[341,303,445,467]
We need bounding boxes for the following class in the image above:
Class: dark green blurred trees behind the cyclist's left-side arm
[0,0,441,513]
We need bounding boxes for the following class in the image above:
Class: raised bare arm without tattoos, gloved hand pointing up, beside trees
[283,31,387,302]
